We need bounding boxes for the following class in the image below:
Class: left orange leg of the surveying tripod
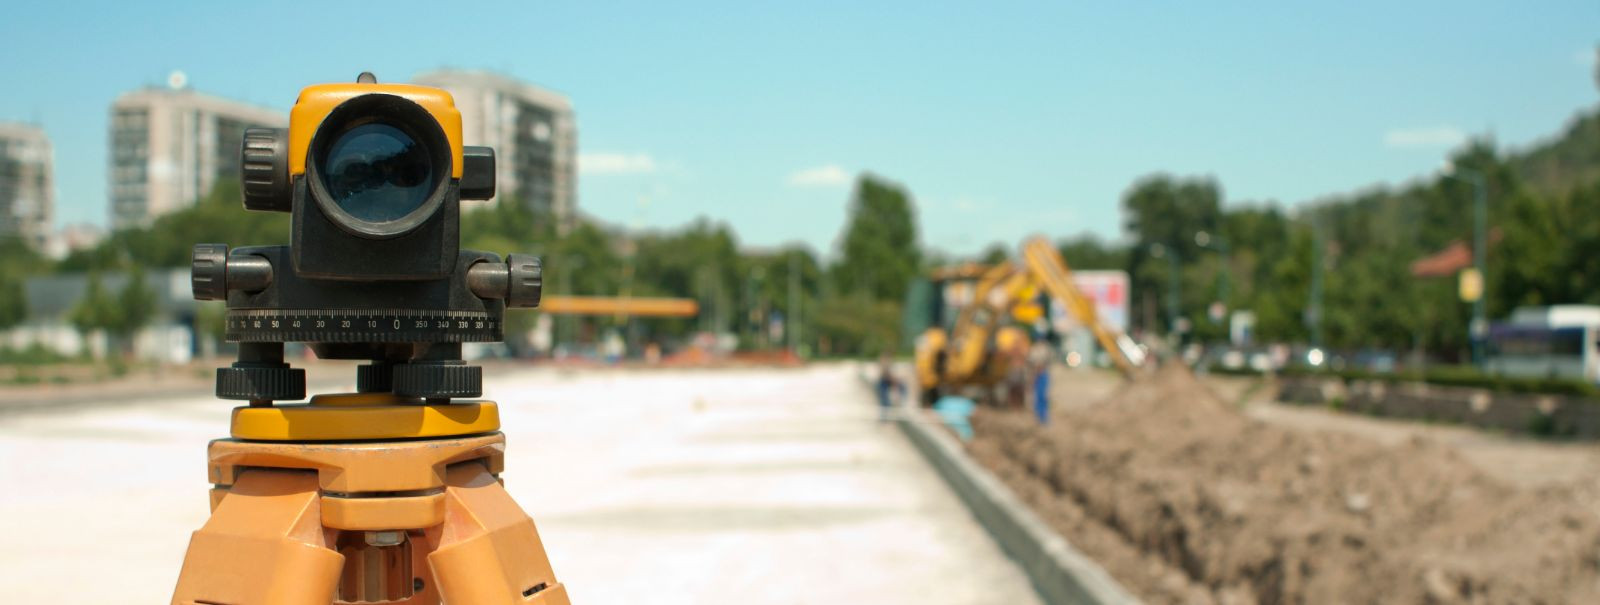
[173,471,344,605]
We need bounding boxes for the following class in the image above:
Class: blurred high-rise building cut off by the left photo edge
[0,123,56,250]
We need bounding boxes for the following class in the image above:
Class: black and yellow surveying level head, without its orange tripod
[192,74,541,405]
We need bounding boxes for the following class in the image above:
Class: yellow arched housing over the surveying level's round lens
[290,83,462,179]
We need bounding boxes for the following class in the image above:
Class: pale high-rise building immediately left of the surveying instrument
[109,86,288,229]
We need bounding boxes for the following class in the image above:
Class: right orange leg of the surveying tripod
[427,461,570,605]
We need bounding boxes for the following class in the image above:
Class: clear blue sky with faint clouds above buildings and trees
[0,0,1600,253]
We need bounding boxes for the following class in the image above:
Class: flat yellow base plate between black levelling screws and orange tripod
[232,394,499,442]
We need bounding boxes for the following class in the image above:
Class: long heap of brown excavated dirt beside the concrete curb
[971,368,1600,603]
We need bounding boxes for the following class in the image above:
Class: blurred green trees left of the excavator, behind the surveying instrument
[0,174,922,355]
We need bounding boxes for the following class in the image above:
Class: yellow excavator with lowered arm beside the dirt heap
[915,237,1144,405]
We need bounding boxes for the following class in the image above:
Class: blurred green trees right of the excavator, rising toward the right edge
[1107,119,1600,360]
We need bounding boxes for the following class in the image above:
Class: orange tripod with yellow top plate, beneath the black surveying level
[173,350,570,605]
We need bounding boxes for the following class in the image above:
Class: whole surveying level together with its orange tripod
[173,74,568,605]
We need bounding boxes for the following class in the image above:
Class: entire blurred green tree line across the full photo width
[0,112,1600,360]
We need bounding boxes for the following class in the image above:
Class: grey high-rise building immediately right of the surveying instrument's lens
[414,69,578,232]
